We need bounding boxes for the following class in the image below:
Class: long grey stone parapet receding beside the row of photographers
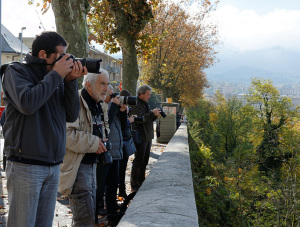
[118,124,199,227]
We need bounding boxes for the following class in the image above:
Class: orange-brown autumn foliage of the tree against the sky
[139,1,218,106]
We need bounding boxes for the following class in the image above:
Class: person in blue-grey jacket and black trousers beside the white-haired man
[96,86,127,224]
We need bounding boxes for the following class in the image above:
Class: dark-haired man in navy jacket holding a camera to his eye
[3,32,87,227]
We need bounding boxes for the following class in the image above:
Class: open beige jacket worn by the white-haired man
[58,90,100,194]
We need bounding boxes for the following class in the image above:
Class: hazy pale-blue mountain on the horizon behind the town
[206,47,300,84]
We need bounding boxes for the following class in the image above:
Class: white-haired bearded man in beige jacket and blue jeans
[59,69,109,227]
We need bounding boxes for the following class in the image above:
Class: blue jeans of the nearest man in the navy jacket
[6,161,59,227]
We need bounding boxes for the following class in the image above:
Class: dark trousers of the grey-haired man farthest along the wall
[130,140,152,191]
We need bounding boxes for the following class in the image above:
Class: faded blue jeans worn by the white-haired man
[69,163,97,227]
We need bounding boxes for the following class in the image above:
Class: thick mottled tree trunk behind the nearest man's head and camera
[51,0,89,87]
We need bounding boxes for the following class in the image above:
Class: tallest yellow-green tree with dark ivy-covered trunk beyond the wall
[247,79,294,178]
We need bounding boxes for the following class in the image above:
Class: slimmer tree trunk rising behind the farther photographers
[120,36,139,95]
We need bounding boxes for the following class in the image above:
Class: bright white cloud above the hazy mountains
[214,6,300,51]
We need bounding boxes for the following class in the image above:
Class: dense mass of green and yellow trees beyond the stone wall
[187,79,300,226]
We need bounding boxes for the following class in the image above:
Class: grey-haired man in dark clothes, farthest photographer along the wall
[130,85,160,192]
